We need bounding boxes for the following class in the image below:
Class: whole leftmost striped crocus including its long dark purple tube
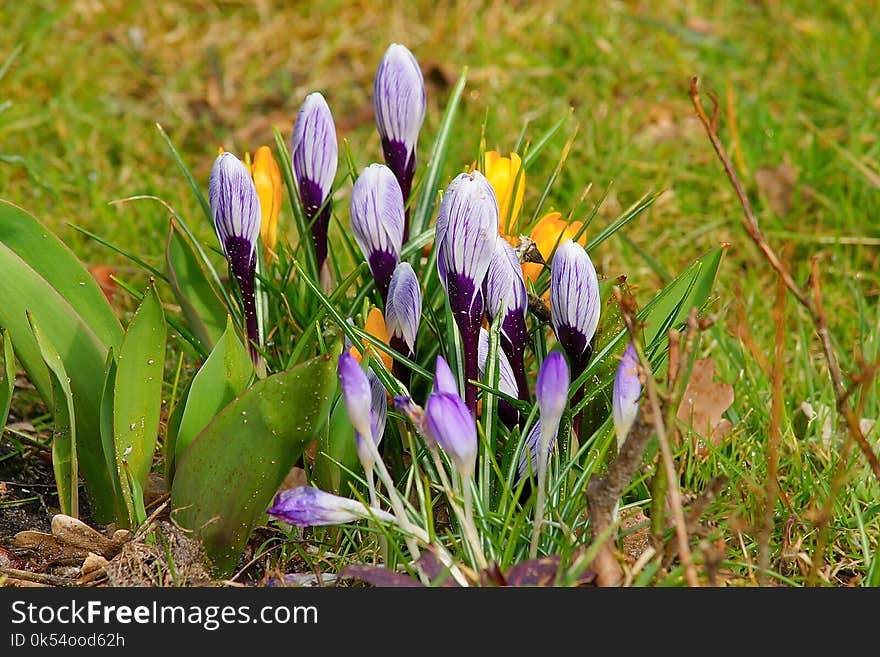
[208,152,262,364]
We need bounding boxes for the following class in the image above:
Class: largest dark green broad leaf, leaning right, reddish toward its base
[171,347,339,576]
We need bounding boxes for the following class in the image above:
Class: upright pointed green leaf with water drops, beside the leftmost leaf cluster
[113,283,166,522]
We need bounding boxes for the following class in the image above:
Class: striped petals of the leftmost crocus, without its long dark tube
[208,152,261,264]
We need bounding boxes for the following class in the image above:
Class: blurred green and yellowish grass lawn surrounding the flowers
[0,0,880,585]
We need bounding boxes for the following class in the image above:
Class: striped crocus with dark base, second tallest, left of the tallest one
[290,91,339,270]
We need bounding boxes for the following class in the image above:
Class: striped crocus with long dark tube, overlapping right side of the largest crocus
[483,237,529,401]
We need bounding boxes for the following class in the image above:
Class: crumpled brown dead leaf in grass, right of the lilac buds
[676,358,733,456]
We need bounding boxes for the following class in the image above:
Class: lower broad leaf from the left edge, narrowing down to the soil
[0,238,116,523]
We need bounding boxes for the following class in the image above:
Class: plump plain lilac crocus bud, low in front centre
[425,392,477,481]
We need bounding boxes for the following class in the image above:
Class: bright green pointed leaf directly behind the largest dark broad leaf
[172,317,254,474]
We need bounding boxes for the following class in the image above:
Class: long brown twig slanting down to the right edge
[690,77,880,481]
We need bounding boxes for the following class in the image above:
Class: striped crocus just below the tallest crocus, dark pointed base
[351,164,404,301]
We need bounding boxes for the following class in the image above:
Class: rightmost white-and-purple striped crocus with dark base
[550,240,601,377]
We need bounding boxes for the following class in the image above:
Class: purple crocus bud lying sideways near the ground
[268,486,396,527]
